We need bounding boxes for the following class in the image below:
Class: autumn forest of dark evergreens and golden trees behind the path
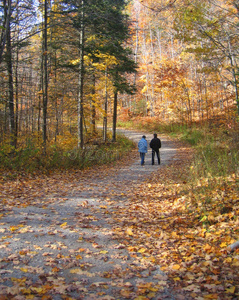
[0,0,239,164]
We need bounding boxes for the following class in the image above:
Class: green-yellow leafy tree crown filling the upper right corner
[175,0,239,114]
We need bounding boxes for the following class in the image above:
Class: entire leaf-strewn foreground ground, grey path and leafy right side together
[0,132,239,300]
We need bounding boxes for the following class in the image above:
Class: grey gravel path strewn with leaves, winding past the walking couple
[0,130,177,300]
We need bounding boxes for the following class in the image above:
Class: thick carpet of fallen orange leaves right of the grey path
[109,148,239,300]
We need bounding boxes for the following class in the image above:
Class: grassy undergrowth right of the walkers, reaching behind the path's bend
[117,115,239,216]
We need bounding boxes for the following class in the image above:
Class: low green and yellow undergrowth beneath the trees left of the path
[0,130,134,176]
